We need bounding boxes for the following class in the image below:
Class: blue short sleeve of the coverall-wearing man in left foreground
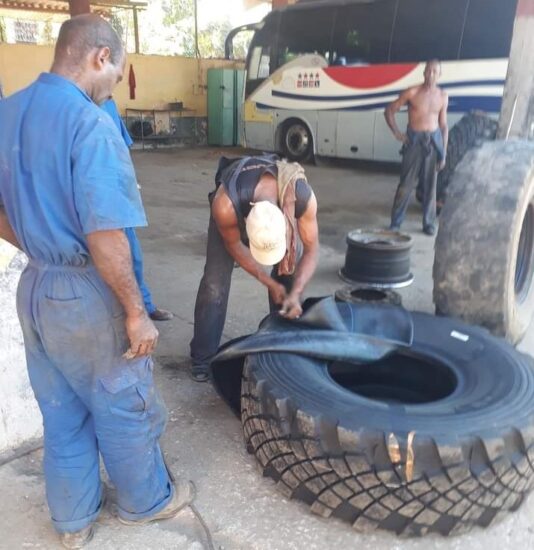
[71,105,147,235]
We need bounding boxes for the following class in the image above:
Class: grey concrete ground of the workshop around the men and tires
[0,149,534,550]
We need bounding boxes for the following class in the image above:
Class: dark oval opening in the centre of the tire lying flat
[328,354,458,405]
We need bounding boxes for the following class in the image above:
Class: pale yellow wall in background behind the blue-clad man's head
[0,44,242,117]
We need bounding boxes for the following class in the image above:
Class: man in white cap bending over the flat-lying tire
[191,155,319,382]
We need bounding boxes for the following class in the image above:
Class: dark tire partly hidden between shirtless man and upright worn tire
[416,111,498,208]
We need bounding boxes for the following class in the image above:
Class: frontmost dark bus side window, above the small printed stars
[275,7,334,68]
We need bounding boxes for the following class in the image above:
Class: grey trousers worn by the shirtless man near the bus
[391,140,438,229]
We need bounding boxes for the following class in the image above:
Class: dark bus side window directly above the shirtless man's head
[390,0,468,63]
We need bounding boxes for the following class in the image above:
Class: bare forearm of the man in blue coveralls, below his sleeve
[87,230,146,317]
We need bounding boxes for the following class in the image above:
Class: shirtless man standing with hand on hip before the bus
[384,59,449,235]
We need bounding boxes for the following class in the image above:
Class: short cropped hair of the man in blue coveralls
[55,14,124,65]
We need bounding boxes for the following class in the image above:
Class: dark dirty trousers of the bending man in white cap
[191,213,301,365]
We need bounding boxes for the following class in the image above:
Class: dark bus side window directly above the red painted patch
[331,0,396,66]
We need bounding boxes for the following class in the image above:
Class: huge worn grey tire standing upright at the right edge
[433,140,534,343]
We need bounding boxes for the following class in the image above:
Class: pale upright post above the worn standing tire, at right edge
[498,0,534,139]
